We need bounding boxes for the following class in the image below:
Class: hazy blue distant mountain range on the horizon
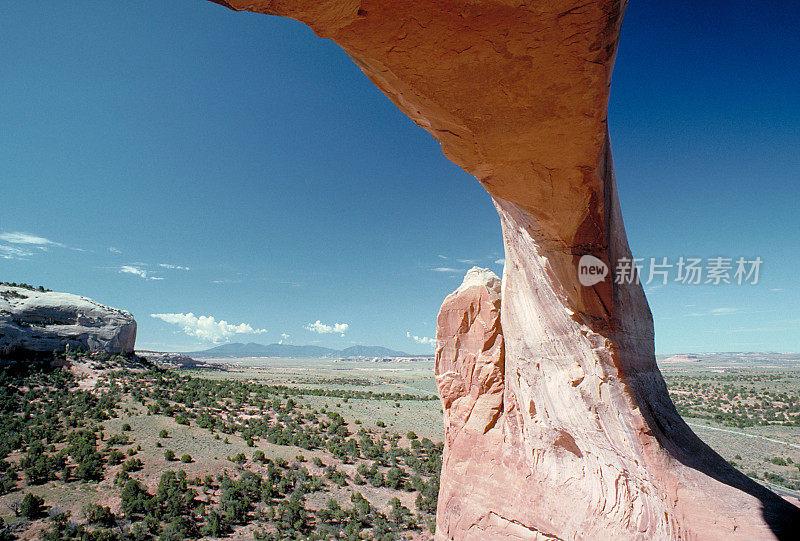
[187,342,414,357]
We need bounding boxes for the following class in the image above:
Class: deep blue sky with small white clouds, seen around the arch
[0,0,800,353]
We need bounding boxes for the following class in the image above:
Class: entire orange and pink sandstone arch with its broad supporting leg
[208,0,798,540]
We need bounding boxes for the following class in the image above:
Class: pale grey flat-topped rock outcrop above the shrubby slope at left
[0,286,136,357]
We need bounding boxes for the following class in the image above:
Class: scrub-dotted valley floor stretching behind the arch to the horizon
[0,354,800,539]
